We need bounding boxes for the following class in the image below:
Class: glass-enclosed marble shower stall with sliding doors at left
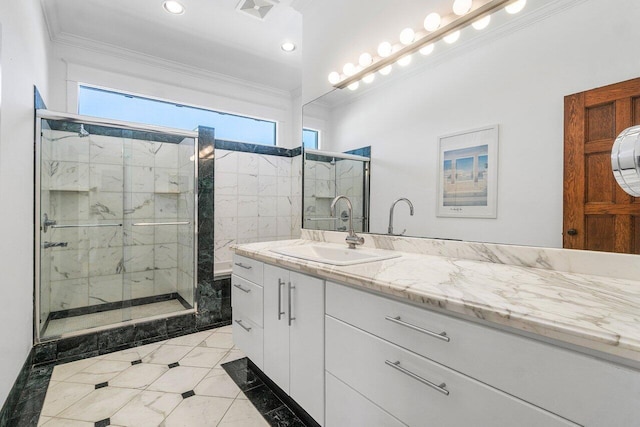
[35,110,198,342]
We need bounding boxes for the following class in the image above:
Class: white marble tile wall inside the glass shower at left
[41,130,194,320]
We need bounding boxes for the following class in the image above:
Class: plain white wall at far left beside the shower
[0,0,50,402]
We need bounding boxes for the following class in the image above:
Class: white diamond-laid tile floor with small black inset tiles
[38,326,269,427]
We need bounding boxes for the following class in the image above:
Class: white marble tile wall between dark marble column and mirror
[214,149,302,272]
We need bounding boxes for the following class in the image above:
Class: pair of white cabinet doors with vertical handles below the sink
[263,264,324,425]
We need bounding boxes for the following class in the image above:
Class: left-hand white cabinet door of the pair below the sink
[263,264,289,394]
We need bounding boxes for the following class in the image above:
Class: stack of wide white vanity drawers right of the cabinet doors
[325,282,640,427]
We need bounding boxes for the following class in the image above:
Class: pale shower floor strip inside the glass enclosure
[43,299,185,337]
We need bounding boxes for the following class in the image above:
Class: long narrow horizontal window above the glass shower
[78,86,276,145]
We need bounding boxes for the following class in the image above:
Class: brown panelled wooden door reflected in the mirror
[563,78,640,254]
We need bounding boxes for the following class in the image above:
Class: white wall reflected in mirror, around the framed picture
[303,0,640,247]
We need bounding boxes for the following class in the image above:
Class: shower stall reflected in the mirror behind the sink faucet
[302,149,371,233]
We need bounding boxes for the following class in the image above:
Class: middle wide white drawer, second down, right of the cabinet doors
[325,316,576,427]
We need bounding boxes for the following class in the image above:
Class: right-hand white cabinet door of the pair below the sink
[289,272,324,425]
